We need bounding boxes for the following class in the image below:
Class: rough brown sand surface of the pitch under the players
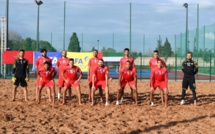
[0,79,215,134]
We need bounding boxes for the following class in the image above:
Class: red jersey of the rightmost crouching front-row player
[150,67,168,85]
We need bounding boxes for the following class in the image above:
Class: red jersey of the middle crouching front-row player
[93,65,109,81]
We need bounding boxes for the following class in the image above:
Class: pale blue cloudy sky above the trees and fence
[0,0,215,53]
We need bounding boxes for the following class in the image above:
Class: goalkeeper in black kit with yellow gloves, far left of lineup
[12,50,29,101]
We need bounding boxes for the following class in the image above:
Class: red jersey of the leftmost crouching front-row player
[38,67,56,81]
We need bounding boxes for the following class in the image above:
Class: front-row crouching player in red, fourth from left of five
[116,60,138,105]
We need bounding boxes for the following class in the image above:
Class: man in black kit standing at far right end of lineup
[181,52,198,106]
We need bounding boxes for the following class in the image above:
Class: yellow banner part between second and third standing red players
[67,52,93,72]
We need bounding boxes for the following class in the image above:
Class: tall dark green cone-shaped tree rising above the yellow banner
[67,32,81,52]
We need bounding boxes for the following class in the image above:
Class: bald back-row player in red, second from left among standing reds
[56,51,71,100]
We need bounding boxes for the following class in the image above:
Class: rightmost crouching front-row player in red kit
[150,60,168,107]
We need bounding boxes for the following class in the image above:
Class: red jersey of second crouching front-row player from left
[63,66,83,81]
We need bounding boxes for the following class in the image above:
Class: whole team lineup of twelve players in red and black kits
[12,48,198,107]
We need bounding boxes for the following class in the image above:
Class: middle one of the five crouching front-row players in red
[91,59,109,106]
